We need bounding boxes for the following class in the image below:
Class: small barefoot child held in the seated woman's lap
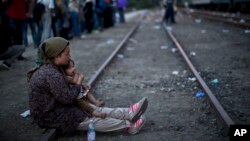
[62,60,106,118]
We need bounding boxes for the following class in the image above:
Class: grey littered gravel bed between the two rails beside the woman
[59,10,232,141]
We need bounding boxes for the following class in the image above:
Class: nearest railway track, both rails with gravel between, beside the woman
[39,9,250,141]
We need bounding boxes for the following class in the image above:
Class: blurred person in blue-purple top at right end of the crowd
[116,0,128,23]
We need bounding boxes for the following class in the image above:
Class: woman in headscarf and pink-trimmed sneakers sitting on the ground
[28,37,148,134]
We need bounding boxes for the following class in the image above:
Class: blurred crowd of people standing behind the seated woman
[0,0,128,69]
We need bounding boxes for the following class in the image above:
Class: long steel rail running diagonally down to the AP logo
[164,24,235,128]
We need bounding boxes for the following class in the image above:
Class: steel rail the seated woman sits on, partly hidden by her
[40,13,146,141]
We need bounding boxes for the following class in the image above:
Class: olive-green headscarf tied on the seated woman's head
[27,37,69,79]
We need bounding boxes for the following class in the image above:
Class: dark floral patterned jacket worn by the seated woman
[28,64,87,134]
